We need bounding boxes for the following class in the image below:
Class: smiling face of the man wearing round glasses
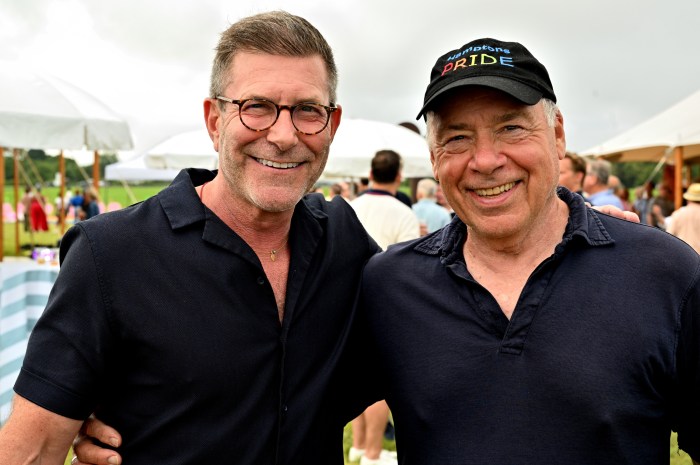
[205,52,341,212]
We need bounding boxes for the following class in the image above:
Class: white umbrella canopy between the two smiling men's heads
[323,118,433,178]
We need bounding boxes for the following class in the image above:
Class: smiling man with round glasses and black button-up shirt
[0,12,378,465]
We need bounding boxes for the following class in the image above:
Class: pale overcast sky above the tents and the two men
[0,0,700,158]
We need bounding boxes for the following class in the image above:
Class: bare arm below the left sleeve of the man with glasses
[0,395,82,465]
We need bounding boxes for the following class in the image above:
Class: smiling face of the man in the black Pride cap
[428,87,566,241]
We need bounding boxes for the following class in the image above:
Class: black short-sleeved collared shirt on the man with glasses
[15,170,377,465]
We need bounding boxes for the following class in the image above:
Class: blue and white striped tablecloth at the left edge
[0,260,58,424]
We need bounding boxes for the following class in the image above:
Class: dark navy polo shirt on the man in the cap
[359,189,700,465]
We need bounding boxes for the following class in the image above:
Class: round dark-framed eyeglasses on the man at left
[216,95,338,136]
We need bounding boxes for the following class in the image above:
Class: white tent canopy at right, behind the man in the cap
[581,90,700,164]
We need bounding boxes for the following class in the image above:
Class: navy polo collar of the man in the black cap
[414,187,615,263]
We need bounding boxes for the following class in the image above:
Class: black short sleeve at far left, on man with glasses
[15,225,113,419]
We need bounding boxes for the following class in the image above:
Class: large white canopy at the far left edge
[0,62,133,150]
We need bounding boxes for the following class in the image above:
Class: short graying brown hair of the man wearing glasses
[209,11,338,104]
